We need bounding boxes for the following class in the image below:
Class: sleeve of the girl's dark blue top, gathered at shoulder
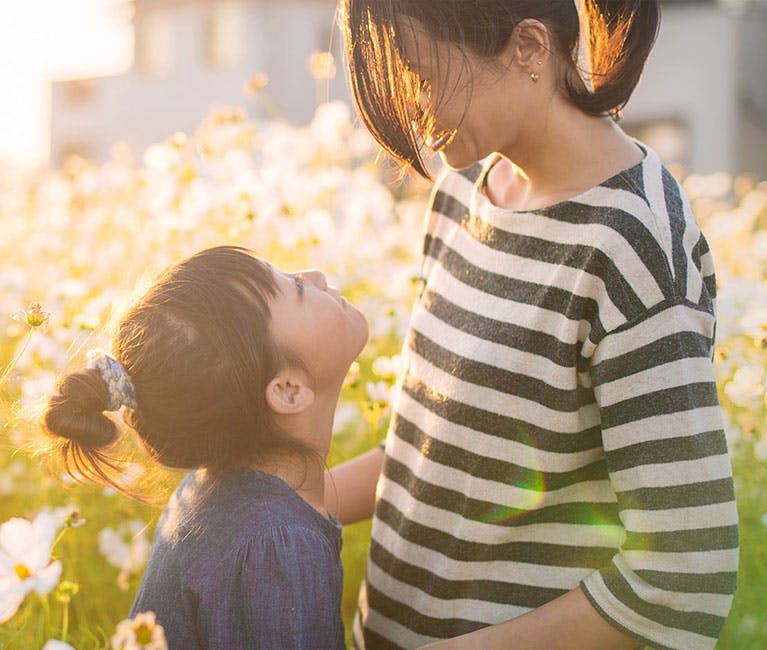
[204,525,345,650]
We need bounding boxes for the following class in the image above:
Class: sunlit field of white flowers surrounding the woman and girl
[0,98,767,650]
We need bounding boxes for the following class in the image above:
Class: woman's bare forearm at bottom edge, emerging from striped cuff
[416,588,642,650]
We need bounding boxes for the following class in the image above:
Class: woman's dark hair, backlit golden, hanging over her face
[343,0,660,177]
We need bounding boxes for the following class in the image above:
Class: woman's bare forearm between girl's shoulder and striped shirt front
[325,447,384,525]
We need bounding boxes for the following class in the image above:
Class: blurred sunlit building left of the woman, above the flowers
[51,0,346,164]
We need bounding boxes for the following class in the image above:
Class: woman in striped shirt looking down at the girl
[326,0,738,649]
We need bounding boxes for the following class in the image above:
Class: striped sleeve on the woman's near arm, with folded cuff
[581,301,738,650]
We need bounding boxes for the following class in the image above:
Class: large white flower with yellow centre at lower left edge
[0,512,61,623]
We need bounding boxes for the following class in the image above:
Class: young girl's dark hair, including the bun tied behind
[43,246,307,496]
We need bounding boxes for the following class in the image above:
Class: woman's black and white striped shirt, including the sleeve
[355,146,738,650]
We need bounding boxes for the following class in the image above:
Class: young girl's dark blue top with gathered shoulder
[130,467,345,650]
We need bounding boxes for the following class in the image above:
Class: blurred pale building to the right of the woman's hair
[624,0,767,178]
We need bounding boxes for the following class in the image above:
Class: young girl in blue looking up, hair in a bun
[44,247,368,650]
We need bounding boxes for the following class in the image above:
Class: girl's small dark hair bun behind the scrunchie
[43,369,118,450]
